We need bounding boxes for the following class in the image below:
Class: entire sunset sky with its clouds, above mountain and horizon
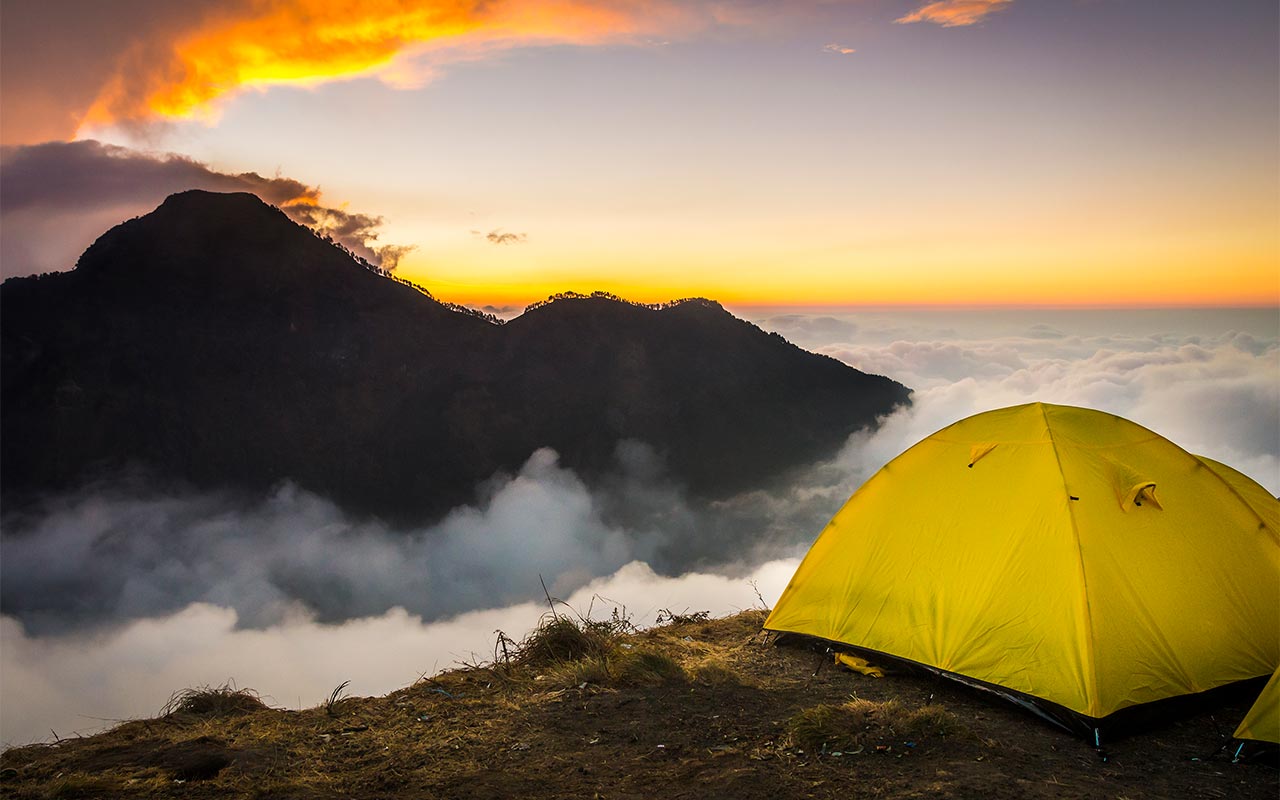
[0,0,1280,307]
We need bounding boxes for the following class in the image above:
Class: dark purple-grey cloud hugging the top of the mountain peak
[0,141,411,278]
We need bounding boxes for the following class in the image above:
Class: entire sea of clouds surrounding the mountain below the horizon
[0,310,1280,745]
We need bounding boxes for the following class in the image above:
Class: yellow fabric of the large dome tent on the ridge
[765,403,1280,718]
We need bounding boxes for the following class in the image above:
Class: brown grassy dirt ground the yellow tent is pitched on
[0,612,1280,800]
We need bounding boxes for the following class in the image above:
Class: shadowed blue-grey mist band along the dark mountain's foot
[0,442,837,634]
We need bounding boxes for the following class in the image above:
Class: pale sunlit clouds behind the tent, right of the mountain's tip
[760,310,1280,494]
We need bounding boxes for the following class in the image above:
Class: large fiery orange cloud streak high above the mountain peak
[83,0,716,125]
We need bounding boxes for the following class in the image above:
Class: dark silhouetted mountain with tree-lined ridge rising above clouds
[0,191,908,522]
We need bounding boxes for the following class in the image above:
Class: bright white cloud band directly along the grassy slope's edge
[0,559,797,745]
